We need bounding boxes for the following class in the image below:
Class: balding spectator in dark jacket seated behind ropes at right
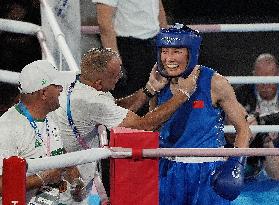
[236,53,279,179]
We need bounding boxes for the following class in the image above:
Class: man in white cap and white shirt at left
[0,60,83,204]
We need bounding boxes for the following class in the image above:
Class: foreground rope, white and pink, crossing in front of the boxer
[26,147,279,173]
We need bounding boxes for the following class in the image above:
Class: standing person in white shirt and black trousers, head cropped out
[92,0,167,115]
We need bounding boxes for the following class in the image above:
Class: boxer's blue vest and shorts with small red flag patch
[157,66,230,205]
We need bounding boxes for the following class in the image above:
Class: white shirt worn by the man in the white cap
[0,106,64,204]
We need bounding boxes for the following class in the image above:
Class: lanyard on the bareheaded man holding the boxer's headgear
[67,79,90,149]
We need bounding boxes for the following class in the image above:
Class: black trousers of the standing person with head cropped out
[112,37,159,115]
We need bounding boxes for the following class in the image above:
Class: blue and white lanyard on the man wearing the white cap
[18,101,50,156]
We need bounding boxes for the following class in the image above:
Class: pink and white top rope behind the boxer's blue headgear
[81,23,279,34]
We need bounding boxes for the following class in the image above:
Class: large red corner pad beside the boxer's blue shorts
[110,128,159,205]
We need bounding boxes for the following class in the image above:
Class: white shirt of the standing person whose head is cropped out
[92,0,160,39]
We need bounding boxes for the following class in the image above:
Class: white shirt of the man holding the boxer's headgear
[55,81,128,187]
